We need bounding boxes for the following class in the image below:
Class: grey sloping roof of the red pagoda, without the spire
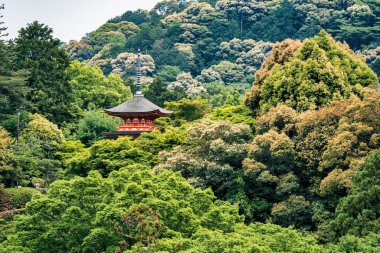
[104,95,173,116]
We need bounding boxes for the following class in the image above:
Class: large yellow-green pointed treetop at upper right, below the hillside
[246,31,378,112]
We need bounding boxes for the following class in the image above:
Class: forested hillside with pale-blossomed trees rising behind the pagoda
[67,0,380,84]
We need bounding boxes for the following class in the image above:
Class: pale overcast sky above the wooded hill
[0,0,159,42]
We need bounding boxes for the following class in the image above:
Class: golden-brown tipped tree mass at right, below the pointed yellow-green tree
[243,88,380,231]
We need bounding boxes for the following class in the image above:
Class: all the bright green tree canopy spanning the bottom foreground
[0,165,319,252]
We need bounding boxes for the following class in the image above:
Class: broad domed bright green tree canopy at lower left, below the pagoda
[1,166,242,252]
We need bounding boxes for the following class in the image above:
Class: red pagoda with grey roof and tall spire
[104,50,173,139]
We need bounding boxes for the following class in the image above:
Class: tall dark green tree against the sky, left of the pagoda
[12,21,79,125]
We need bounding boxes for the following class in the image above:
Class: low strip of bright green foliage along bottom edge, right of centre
[126,223,321,253]
